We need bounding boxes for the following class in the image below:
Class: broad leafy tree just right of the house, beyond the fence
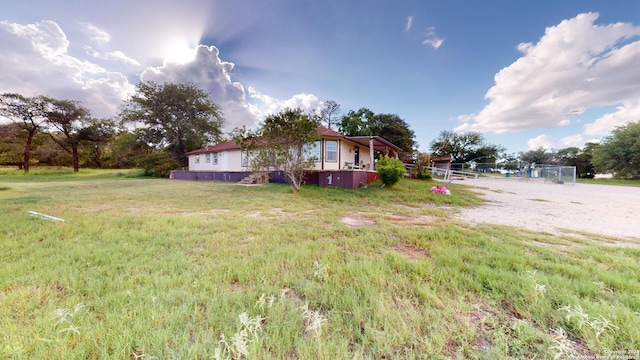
[430,130,489,163]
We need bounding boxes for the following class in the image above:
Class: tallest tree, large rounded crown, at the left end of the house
[120,81,224,167]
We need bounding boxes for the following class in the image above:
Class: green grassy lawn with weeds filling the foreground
[0,169,640,359]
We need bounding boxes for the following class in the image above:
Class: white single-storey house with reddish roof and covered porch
[171,126,400,188]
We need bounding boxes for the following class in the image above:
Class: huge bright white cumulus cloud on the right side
[456,13,640,135]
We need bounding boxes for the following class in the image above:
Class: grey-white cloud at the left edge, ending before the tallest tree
[0,20,134,117]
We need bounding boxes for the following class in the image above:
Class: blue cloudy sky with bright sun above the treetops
[0,0,640,154]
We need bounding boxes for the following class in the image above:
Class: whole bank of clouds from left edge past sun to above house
[0,21,321,131]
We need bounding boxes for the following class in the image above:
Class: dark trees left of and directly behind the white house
[0,82,417,176]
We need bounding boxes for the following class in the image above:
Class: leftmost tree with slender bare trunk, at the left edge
[0,93,46,173]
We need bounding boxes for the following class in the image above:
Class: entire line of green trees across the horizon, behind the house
[0,82,640,178]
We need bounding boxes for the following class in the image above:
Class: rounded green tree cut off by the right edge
[593,121,640,179]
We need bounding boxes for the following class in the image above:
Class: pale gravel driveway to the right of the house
[457,178,640,240]
